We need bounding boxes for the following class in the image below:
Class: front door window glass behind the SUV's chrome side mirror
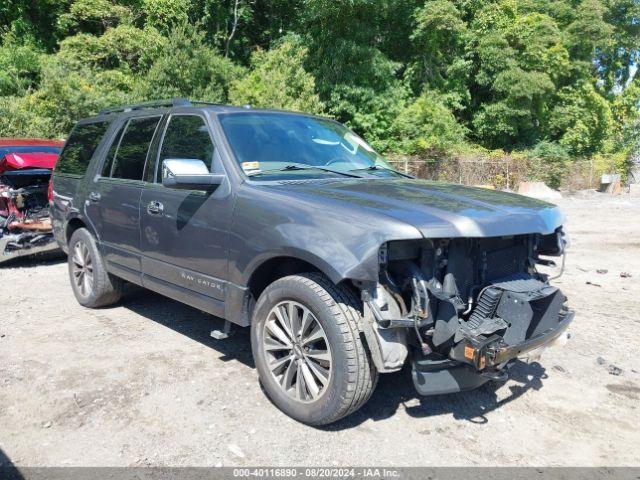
[156,115,214,183]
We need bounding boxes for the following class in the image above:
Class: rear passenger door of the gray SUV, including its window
[86,115,161,283]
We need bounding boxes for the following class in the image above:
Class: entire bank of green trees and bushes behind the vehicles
[0,0,640,186]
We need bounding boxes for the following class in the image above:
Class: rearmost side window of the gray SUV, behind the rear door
[55,122,109,175]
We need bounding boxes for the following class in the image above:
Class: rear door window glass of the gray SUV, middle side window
[107,117,160,180]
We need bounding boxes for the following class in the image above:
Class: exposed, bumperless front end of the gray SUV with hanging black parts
[362,228,573,395]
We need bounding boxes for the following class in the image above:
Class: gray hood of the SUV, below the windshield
[275,179,564,238]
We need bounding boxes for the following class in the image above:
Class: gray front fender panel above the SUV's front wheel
[229,188,422,286]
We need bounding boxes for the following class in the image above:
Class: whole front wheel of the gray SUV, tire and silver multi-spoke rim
[251,273,378,426]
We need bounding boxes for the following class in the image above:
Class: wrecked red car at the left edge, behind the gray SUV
[0,138,63,263]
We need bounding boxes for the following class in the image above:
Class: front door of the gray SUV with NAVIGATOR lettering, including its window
[140,114,232,304]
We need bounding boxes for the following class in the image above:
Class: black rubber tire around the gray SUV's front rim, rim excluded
[251,273,378,425]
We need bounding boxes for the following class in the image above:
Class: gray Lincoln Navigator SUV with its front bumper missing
[52,99,573,425]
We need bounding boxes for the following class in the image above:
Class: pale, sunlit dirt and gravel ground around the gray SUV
[0,194,640,466]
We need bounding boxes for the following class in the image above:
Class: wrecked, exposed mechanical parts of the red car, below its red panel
[0,169,58,263]
